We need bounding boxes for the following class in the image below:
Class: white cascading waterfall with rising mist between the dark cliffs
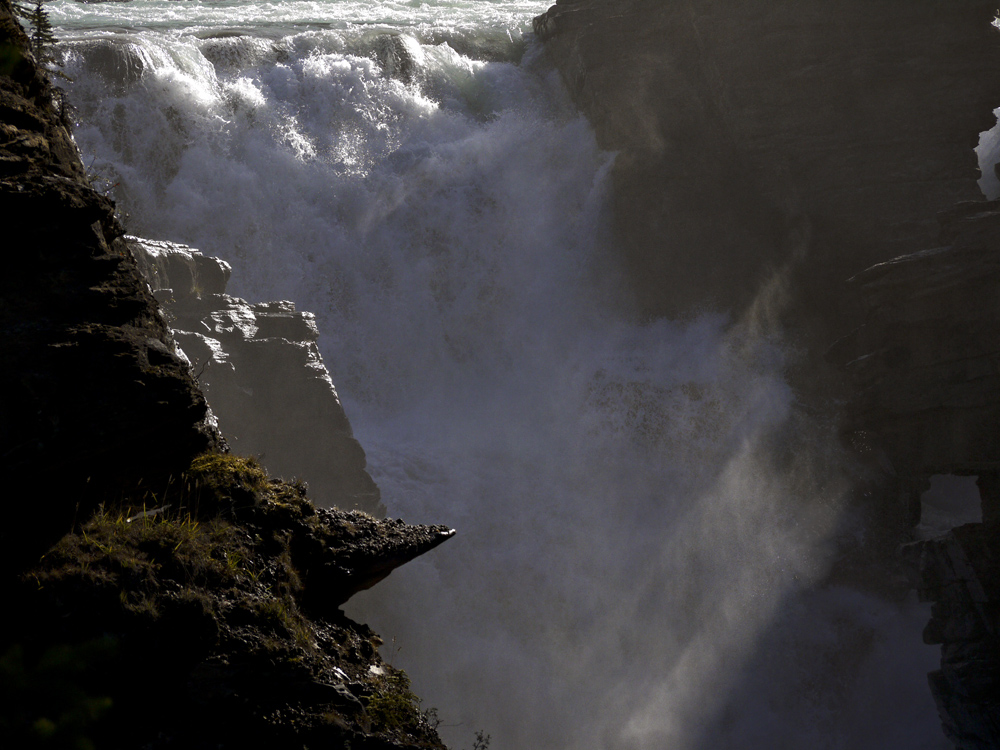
[49,0,948,750]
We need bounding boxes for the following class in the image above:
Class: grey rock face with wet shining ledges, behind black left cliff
[126,237,385,517]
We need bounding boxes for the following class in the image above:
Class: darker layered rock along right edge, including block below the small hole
[829,201,1000,750]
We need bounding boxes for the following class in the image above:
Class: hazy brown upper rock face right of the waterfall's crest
[535,0,1000,314]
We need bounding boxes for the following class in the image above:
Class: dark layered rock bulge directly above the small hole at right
[828,201,1000,518]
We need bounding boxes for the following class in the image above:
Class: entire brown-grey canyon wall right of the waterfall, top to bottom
[535,0,1000,750]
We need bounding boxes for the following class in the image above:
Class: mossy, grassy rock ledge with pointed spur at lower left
[0,453,447,749]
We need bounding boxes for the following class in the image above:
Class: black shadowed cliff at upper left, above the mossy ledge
[0,3,222,563]
